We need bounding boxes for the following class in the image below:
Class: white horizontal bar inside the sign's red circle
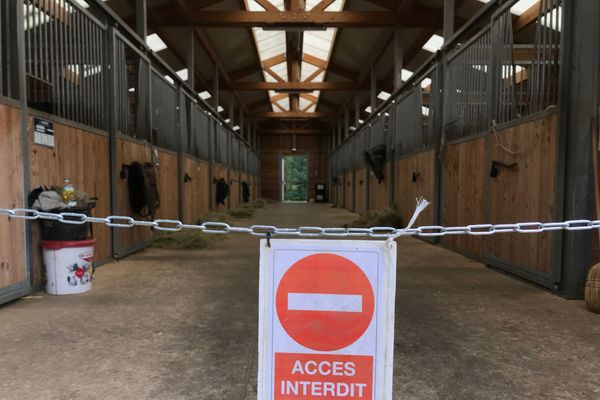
[288,293,362,312]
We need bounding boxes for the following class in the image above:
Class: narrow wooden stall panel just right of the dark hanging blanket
[156,150,179,219]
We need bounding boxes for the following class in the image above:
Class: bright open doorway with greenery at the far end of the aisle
[281,155,308,202]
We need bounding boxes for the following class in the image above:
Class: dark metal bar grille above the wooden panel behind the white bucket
[24,0,106,129]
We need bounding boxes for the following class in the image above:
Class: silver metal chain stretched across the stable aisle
[0,208,600,239]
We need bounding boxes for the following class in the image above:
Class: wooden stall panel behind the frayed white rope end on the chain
[394,150,437,225]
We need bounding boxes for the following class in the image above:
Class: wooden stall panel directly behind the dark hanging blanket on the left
[115,137,152,249]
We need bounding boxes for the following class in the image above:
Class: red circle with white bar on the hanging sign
[275,254,374,351]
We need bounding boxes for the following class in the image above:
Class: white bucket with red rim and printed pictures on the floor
[42,239,96,294]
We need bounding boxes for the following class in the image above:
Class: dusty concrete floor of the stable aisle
[0,204,600,400]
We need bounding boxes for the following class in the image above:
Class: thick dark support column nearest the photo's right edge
[553,0,600,298]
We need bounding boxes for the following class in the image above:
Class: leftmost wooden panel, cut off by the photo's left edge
[0,104,27,288]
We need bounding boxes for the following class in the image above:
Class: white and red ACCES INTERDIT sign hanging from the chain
[258,240,396,400]
